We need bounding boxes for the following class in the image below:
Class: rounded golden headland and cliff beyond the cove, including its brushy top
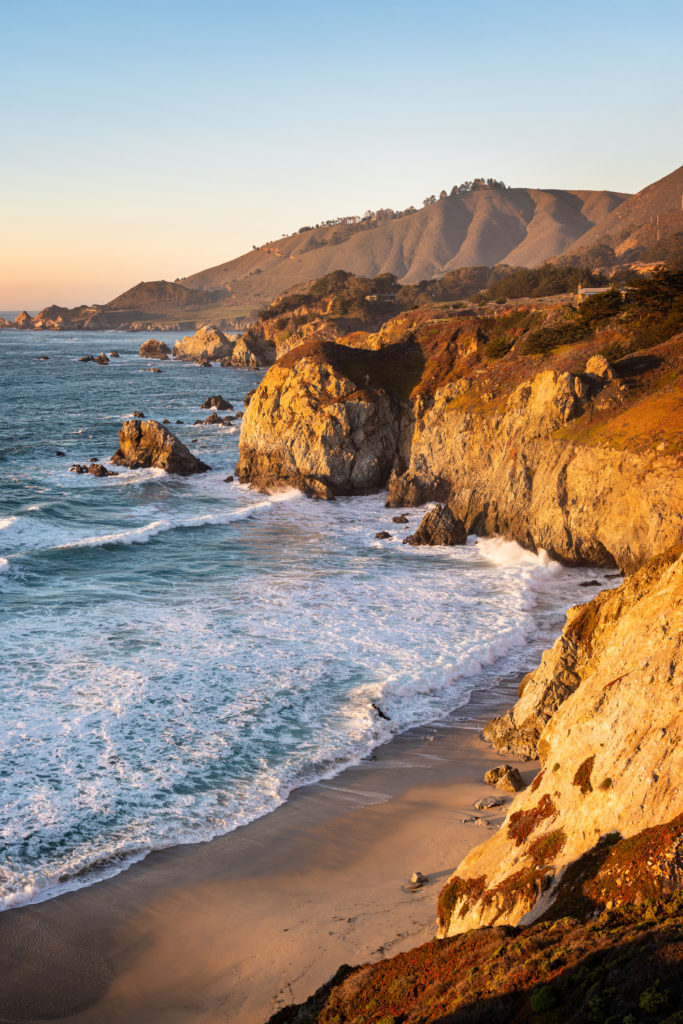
[239,292,683,571]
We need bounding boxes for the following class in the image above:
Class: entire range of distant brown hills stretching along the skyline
[7,169,683,331]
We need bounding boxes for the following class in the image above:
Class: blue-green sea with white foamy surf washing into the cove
[0,331,618,907]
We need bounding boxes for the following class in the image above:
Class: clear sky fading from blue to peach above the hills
[0,0,683,310]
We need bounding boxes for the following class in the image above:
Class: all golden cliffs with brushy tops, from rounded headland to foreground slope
[255,270,683,1024]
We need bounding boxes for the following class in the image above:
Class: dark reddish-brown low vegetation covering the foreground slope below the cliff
[269,815,683,1024]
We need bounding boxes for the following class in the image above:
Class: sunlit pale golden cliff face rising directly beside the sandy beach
[439,548,683,936]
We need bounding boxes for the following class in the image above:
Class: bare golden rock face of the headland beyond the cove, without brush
[236,328,683,571]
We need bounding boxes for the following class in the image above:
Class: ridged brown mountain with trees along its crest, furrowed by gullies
[180,187,626,305]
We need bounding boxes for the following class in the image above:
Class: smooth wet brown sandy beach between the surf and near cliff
[0,682,536,1024]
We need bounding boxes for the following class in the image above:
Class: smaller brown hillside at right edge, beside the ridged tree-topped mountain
[566,167,683,260]
